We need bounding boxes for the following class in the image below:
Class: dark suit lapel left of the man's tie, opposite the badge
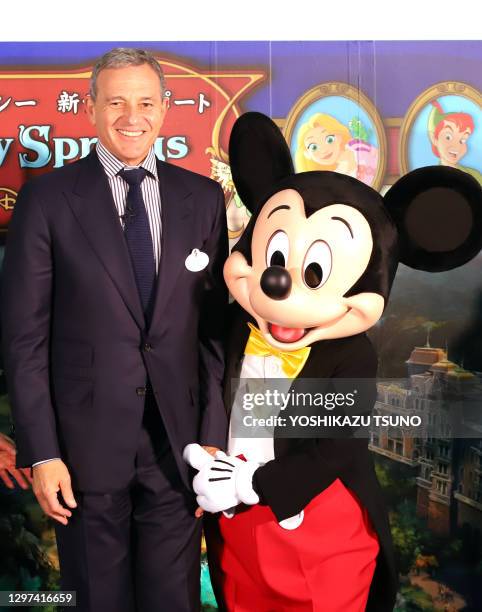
[68,151,145,329]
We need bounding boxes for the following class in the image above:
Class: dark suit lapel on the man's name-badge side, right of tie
[151,160,196,329]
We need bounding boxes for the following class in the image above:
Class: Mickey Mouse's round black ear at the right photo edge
[384,166,482,272]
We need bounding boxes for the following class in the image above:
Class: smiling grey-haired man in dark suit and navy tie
[2,49,227,612]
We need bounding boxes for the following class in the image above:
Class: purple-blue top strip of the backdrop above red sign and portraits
[0,41,482,117]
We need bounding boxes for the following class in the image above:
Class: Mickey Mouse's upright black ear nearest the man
[229,112,294,213]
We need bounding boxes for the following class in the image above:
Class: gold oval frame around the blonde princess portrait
[283,81,387,190]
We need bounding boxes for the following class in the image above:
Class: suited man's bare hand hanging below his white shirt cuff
[33,459,77,525]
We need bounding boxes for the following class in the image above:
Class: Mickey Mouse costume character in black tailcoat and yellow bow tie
[184,113,482,612]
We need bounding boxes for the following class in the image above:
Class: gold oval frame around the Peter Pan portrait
[398,81,482,176]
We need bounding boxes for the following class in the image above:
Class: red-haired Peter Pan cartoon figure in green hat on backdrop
[428,100,482,185]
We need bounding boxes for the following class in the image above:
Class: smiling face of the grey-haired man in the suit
[86,64,168,166]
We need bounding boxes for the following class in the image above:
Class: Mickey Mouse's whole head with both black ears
[224,113,482,350]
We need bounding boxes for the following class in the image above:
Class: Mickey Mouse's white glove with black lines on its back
[183,444,259,512]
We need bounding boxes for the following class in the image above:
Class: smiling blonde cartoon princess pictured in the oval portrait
[295,113,378,185]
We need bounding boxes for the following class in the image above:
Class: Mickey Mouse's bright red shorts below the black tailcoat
[206,479,379,612]
